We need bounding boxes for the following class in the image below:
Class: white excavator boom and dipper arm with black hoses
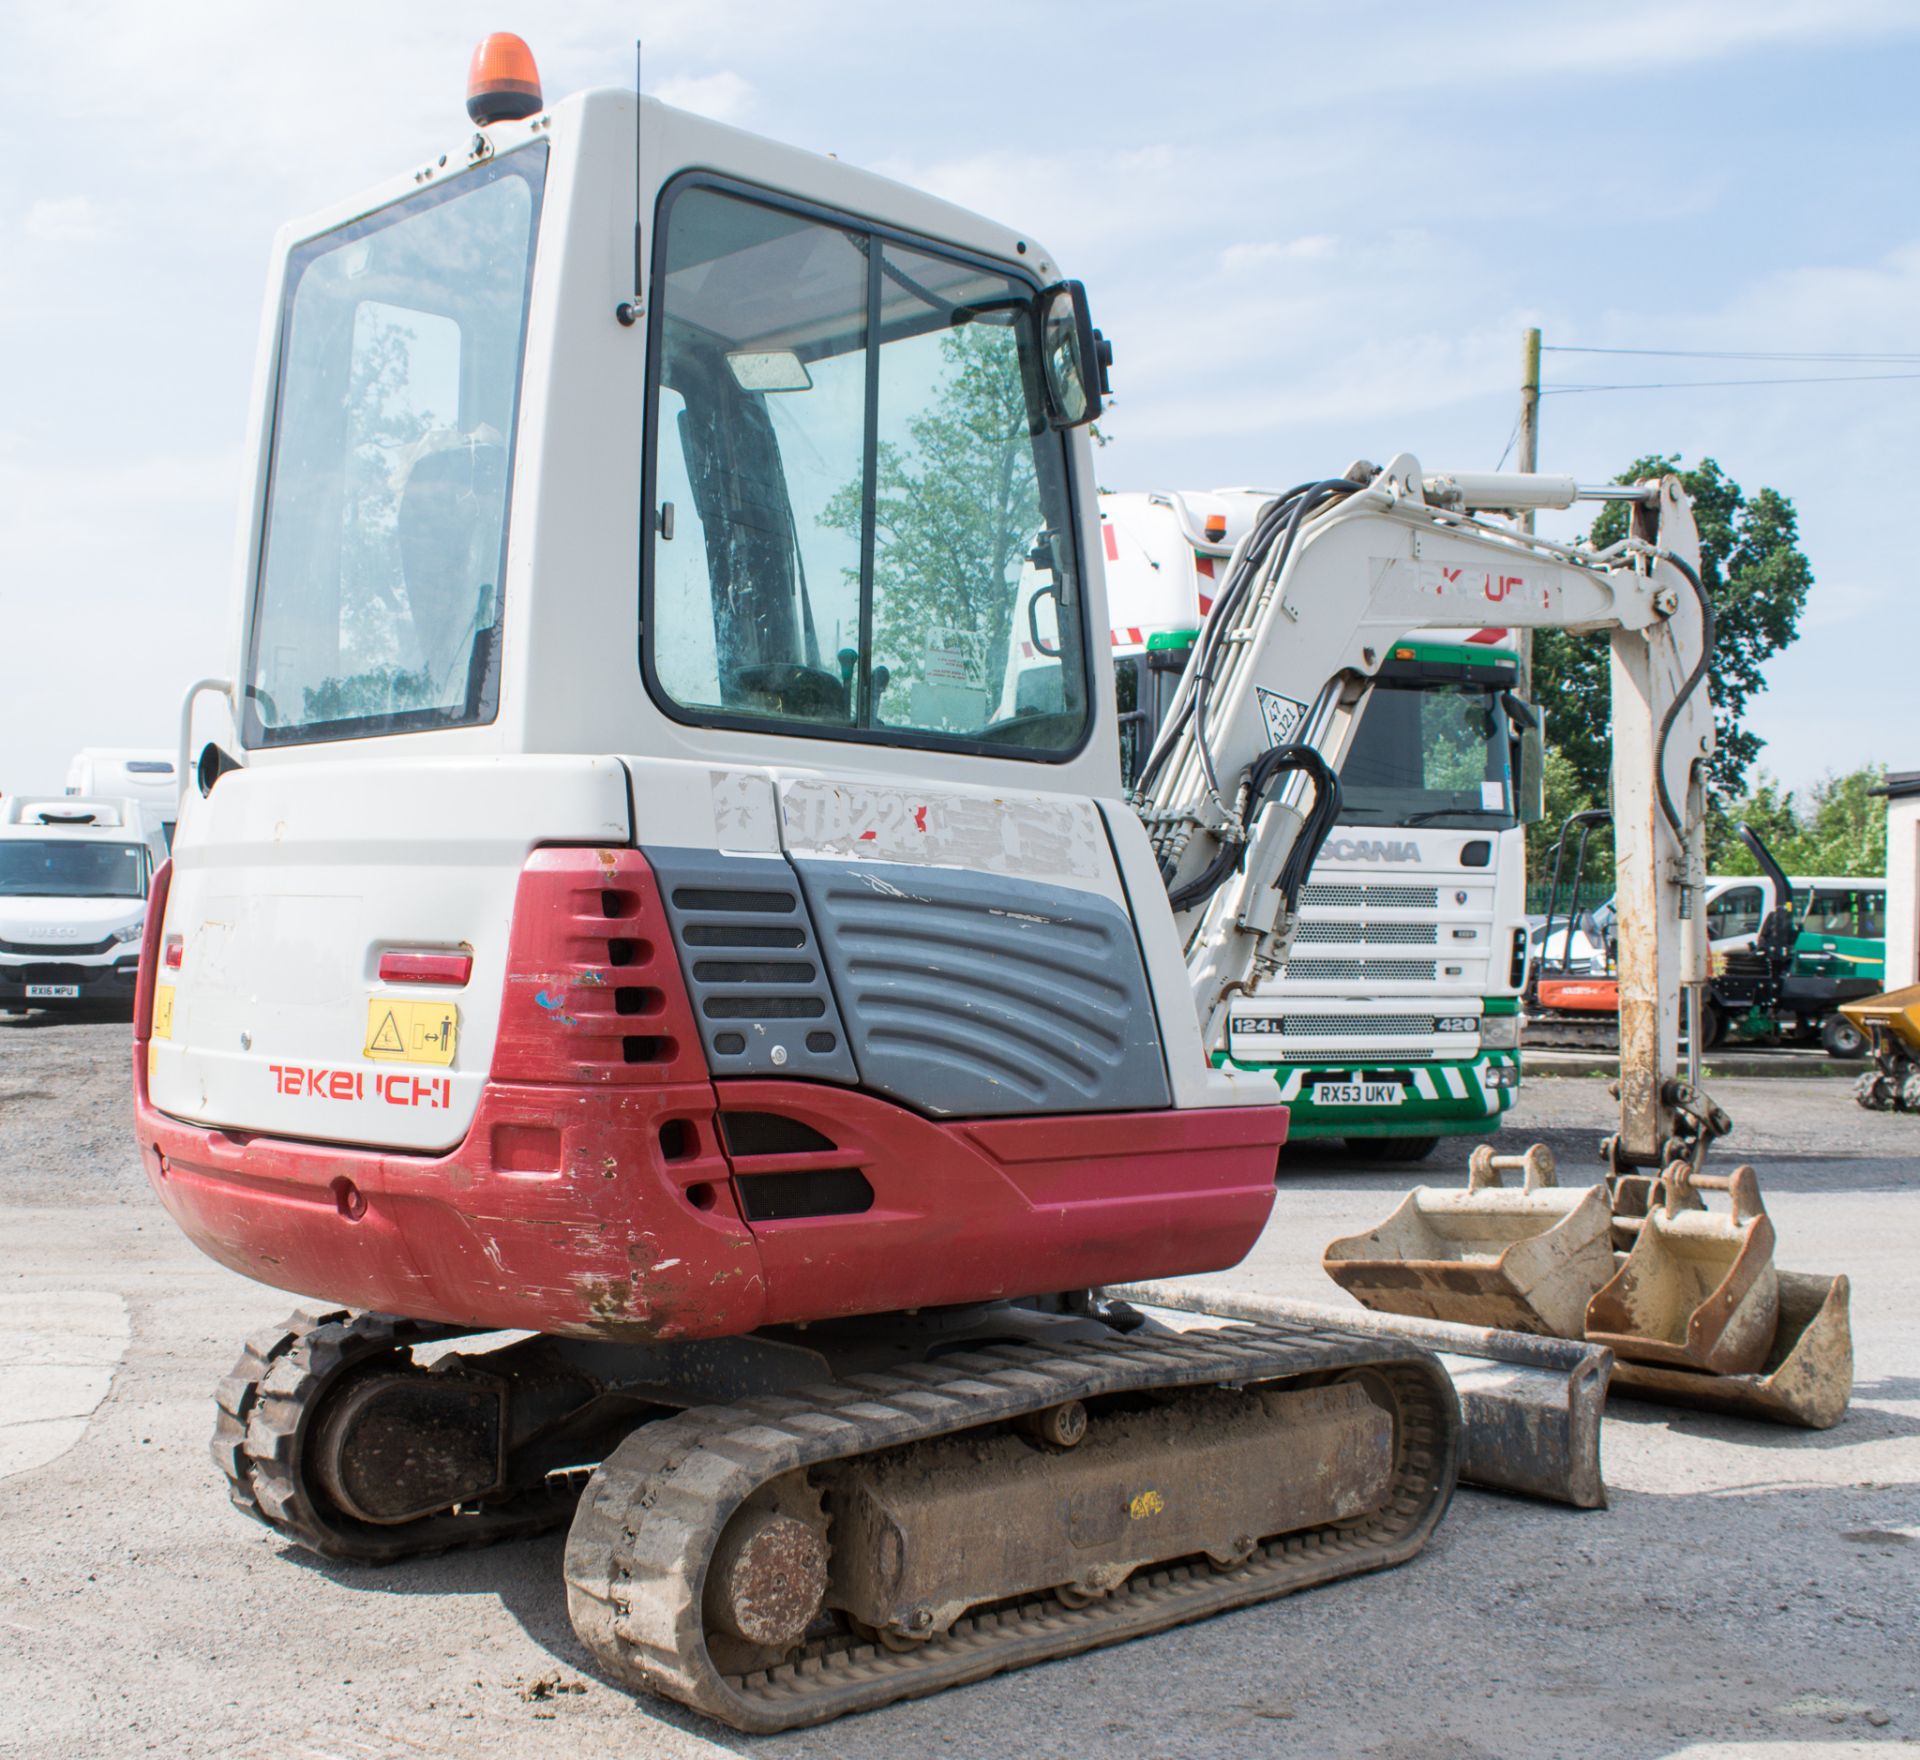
[1135,455,1713,1161]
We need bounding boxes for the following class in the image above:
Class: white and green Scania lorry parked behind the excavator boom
[1100,489,1540,1159]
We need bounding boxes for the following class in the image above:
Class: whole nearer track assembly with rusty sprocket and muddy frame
[566,1326,1459,1733]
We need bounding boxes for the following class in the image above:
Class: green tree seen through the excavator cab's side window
[820,324,1041,679]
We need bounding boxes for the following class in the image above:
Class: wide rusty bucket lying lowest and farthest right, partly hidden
[1612,1271,1853,1420]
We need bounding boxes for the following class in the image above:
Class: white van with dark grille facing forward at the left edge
[0,795,167,1013]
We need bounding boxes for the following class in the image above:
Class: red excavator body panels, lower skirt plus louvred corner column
[134,850,1286,1338]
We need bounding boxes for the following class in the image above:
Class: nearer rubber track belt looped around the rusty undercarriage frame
[566,1326,1459,1735]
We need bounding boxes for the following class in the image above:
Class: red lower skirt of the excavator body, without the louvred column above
[134,1067,1286,1338]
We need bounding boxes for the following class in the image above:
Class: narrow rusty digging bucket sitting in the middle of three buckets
[1586,1163,1780,1374]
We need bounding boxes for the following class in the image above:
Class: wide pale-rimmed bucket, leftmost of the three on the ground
[1321,1144,1613,1338]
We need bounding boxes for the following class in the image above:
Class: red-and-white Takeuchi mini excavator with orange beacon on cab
[134,38,1843,1731]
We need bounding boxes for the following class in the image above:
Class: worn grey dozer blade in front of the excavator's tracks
[1104,1284,1613,1509]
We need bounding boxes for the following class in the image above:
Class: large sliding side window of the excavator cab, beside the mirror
[643,180,1087,758]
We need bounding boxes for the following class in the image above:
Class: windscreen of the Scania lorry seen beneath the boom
[1340,681,1517,831]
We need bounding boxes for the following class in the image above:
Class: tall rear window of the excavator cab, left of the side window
[246,146,547,745]
